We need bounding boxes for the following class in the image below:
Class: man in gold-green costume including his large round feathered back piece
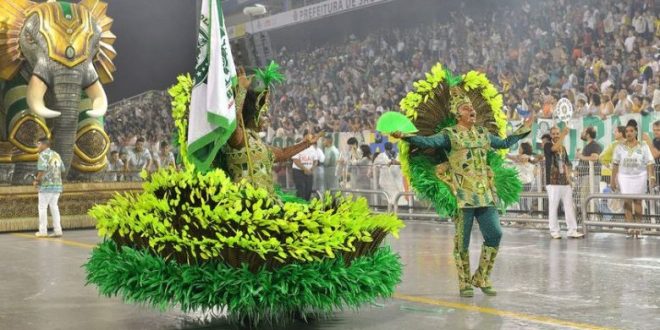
[386,64,532,297]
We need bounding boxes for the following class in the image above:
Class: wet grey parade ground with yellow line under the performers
[0,221,660,330]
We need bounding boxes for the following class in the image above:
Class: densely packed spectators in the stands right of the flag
[269,0,660,137]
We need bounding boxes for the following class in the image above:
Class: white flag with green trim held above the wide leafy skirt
[188,0,236,172]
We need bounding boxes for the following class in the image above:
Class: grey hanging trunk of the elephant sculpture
[45,69,82,177]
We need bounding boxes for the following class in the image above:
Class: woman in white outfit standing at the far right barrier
[612,119,655,238]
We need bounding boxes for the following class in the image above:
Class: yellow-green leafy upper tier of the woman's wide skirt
[90,167,403,269]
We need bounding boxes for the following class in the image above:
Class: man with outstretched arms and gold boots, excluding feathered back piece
[392,86,533,297]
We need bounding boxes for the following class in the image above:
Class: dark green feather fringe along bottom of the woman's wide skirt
[84,240,402,325]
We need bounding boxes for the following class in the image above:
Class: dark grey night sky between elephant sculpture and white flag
[102,0,197,103]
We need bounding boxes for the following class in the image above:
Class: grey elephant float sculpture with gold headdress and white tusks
[0,0,116,184]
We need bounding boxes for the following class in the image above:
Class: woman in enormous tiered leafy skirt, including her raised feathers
[85,66,403,325]
